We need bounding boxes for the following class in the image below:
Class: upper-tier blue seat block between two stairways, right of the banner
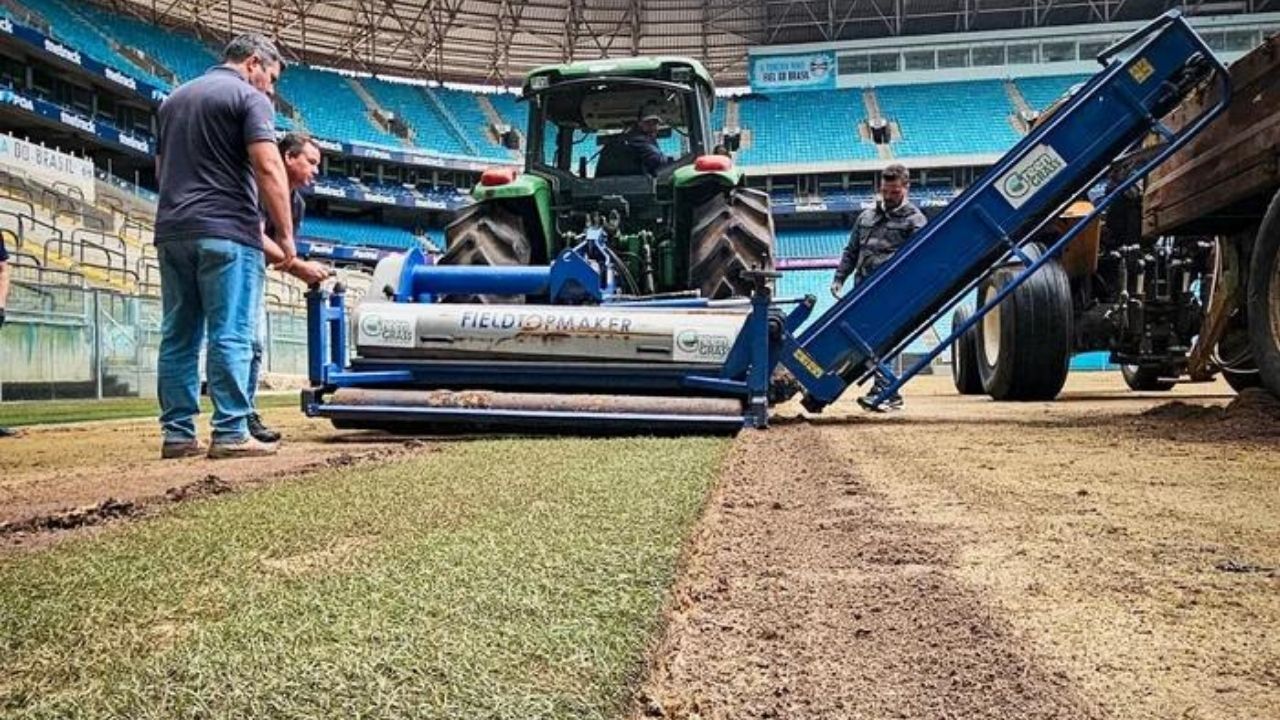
[876,79,1019,158]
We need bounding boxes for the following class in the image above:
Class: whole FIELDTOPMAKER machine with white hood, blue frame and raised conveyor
[302,12,1231,433]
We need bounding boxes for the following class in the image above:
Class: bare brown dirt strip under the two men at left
[0,399,422,550]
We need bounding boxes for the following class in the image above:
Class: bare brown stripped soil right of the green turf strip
[632,374,1280,720]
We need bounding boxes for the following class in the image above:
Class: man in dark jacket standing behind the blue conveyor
[831,163,925,409]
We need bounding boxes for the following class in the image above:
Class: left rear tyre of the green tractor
[438,202,532,304]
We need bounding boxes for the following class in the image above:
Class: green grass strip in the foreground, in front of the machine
[0,438,728,719]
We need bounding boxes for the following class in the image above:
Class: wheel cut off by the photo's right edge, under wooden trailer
[1244,184,1280,397]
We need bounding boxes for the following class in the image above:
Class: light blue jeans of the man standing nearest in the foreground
[156,238,266,442]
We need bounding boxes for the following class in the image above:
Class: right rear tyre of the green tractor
[689,187,774,300]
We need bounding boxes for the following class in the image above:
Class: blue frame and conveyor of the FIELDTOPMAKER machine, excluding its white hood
[303,12,1230,432]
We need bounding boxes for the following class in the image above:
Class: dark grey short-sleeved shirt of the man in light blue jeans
[156,65,275,249]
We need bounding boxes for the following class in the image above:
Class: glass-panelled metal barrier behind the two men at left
[0,280,307,401]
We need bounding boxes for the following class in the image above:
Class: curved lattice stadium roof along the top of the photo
[99,0,1280,86]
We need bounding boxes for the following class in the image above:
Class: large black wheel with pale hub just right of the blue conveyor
[975,260,1073,400]
